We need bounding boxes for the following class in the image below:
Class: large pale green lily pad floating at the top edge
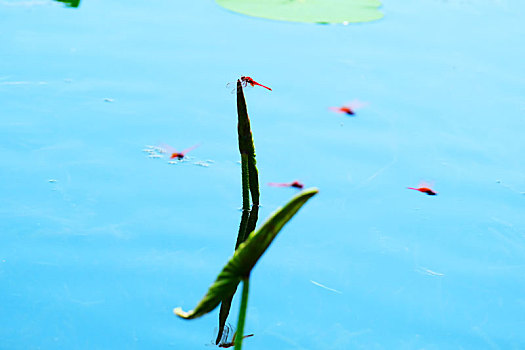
[216,0,383,24]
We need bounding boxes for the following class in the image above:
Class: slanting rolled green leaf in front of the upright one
[173,188,319,319]
